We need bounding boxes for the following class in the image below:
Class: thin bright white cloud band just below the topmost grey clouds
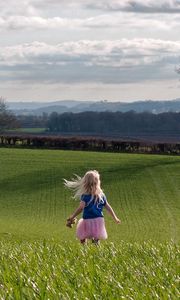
[0,13,173,30]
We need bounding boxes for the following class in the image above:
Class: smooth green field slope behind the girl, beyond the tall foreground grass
[0,148,180,241]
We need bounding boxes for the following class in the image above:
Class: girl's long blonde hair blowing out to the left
[64,170,104,201]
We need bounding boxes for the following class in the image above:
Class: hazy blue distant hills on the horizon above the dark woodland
[8,98,180,115]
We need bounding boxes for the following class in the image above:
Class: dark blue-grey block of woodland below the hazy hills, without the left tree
[47,111,180,135]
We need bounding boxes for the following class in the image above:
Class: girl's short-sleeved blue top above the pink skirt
[81,194,106,219]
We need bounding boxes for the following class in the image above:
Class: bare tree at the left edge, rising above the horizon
[0,97,19,131]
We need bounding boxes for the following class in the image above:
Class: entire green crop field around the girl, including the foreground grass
[0,148,180,300]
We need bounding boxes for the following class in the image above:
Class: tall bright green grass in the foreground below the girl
[0,241,179,300]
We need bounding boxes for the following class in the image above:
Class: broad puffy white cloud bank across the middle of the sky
[0,39,180,67]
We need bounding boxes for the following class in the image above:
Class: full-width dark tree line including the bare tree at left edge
[0,97,180,136]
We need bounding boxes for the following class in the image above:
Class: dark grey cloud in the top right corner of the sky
[86,0,180,13]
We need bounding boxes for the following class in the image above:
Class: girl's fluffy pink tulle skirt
[76,217,107,240]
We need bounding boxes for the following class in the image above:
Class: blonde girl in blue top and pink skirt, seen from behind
[64,170,121,244]
